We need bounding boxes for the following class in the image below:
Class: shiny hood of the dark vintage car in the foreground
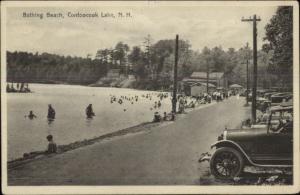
[224,128,267,141]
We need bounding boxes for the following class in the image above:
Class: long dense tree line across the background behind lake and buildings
[7,43,267,89]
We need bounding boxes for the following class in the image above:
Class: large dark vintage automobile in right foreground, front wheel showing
[210,106,293,179]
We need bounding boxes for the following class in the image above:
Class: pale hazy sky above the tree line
[6,3,277,57]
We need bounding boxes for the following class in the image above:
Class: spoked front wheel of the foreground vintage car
[210,147,244,179]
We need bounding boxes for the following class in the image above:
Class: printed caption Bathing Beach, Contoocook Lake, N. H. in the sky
[22,11,132,19]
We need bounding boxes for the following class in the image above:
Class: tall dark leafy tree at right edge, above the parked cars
[263,6,293,87]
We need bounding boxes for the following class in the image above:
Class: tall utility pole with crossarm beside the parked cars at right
[242,14,260,124]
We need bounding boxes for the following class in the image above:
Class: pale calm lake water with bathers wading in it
[7,84,171,160]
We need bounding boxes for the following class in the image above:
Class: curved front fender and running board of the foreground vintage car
[211,140,292,167]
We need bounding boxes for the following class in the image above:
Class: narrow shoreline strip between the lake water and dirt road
[7,101,216,170]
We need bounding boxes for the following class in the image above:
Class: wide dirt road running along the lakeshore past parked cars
[8,97,249,185]
